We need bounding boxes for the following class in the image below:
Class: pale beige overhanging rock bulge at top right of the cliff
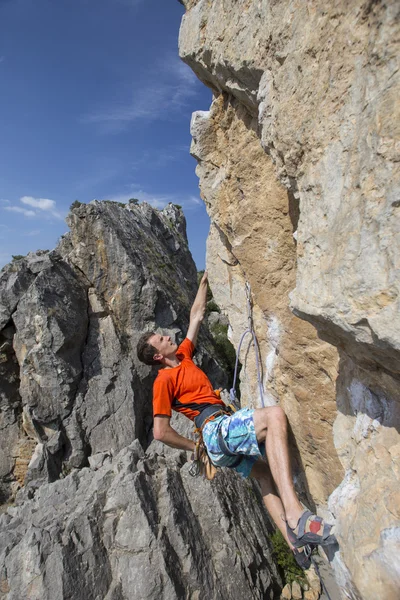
[180,0,400,373]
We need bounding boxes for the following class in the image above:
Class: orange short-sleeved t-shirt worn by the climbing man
[153,338,225,421]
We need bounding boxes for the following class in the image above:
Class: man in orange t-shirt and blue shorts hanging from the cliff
[137,272,337,568]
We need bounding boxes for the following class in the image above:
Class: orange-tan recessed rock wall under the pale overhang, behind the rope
[191,95,343,504]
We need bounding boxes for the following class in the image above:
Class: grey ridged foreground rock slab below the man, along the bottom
[0,440,282,600]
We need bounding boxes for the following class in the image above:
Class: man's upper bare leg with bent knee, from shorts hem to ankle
[254,406,304,537]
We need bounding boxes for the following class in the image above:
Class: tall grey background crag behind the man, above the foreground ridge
[0,202,225,500]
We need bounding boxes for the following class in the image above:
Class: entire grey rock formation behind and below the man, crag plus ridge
[0,201,282,600]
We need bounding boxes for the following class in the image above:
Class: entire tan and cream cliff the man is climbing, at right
[180,0,400,600]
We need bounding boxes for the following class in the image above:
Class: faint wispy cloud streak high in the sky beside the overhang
[83,55,199,133]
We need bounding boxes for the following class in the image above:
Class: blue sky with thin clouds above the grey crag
[0,0,211,269]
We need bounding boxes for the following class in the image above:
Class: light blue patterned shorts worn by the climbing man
[203,408,265,477]
